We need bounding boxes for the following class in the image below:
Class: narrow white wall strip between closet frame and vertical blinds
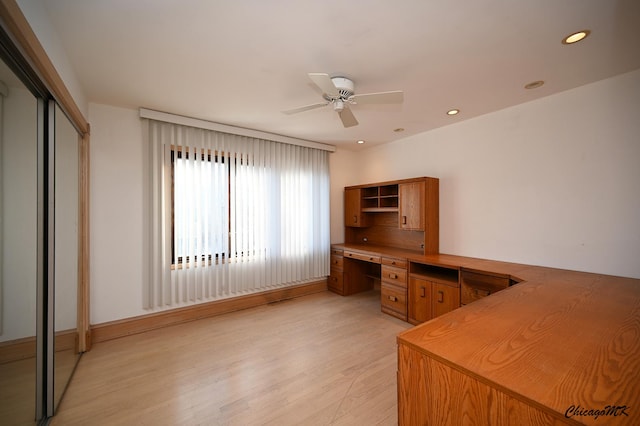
[89,104,147,324]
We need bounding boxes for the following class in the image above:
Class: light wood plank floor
[51,291,410,426]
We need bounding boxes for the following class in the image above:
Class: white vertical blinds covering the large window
[144,119,330,308]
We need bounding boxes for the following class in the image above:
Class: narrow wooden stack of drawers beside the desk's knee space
[380,257,407,321]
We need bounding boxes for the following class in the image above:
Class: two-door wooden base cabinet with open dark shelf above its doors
[407,262,460,324]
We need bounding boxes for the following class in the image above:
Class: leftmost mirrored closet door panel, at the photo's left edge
[0,51,39,424]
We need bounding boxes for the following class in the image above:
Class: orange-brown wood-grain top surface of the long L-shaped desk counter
[332,246,640,424]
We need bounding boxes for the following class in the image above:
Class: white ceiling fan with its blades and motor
[283,73,404,127]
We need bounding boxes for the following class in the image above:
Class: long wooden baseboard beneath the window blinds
[91,278,327,343]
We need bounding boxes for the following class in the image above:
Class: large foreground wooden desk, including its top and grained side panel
[398,255,640,425]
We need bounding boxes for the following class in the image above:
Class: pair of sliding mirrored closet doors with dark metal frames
[0,34,83,425]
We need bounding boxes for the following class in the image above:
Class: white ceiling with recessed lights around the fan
[44,0,640,149]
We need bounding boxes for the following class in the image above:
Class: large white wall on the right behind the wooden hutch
[332,70,640,278]
